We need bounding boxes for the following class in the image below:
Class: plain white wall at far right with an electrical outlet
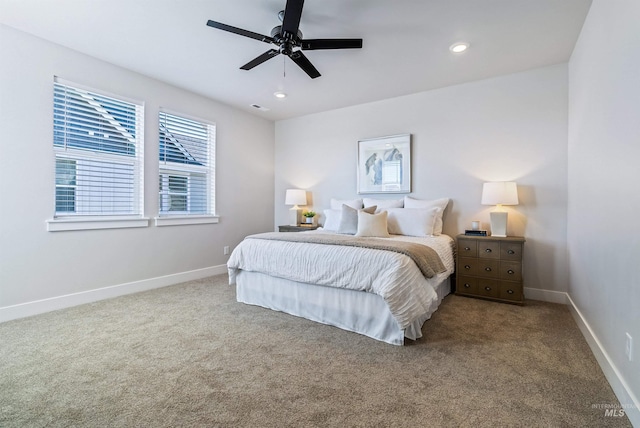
[568,0,640,426]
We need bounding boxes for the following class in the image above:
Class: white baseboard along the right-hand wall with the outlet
[567,294,640,427]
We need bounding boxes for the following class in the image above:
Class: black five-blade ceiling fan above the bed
[207,0,362,79]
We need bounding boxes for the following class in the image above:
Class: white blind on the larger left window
[53,80,144,217]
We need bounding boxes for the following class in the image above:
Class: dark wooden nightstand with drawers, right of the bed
[456,235,525,305]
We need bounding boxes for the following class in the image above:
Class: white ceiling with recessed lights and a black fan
[0,0,591,120]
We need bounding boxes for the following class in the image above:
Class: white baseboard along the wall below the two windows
[0,265,227,322]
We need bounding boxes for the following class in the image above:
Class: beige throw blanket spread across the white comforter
[245,232,446,278]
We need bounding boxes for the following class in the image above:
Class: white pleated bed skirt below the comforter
[236,271,451,346]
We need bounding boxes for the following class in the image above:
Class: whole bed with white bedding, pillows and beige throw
[227,196,454,345]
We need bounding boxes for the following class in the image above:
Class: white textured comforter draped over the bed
[227,230,454,329]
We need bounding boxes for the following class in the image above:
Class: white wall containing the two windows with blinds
[0,26,274,319]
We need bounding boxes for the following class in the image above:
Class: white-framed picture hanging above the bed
[357,134,411,194]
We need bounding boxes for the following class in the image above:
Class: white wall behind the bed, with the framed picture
[275,64,568,299]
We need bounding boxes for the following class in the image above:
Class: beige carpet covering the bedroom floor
[0,275,630,427]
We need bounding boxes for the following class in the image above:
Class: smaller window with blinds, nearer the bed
[158,112,215,216]
